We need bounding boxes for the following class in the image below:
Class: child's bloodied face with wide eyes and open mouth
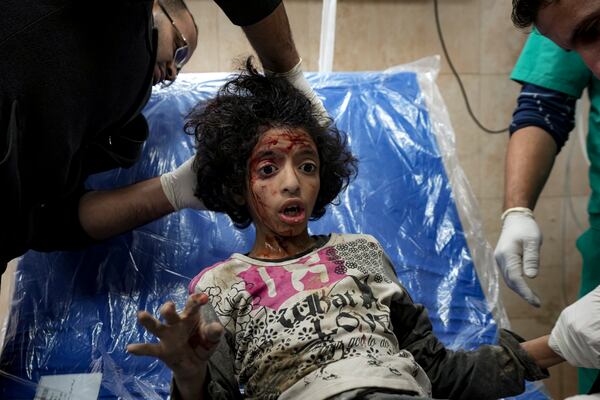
[245,128,320,237]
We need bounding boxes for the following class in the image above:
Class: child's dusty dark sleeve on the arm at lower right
[391,294,549,400]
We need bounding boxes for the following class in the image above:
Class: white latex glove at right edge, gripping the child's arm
[548,286,600,369]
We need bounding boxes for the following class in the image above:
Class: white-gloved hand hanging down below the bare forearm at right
[494,207,542,307]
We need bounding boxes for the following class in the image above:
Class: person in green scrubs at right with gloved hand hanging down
[495,0,600,393]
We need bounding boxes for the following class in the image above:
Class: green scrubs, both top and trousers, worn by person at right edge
[511,30,600,393]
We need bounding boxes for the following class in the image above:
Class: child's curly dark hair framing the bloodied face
[185,57,358,228]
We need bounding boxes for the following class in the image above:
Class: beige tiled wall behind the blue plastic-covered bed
[0,0,589,399]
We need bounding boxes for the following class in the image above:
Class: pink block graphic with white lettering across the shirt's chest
[238,249,346,310]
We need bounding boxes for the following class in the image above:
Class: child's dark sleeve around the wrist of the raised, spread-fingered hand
[171,334,242,400]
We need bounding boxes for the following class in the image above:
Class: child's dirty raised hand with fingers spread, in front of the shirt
[127,294,223,399]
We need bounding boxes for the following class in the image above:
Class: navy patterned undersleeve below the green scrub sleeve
[510,83,577,153]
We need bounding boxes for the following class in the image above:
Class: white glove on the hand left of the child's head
[160,156,206,211]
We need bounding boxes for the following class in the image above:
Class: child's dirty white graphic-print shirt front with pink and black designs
[190,234,431,400]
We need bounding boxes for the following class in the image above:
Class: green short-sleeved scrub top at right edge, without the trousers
[511,30,600,229]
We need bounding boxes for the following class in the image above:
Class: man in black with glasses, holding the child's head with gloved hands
[0,0,322,273]
